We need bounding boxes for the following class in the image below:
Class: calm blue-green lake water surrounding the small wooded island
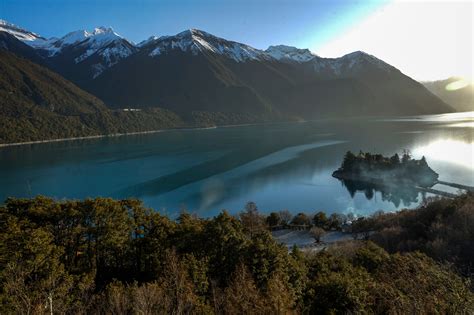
[0,112,474,217]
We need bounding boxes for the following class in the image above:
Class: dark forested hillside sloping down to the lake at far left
[0,50,183,143]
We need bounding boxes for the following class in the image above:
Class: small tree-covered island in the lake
[332,151,439,188]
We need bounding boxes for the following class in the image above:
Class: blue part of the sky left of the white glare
[0,0,386,49]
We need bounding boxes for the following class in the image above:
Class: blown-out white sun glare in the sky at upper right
[314,0,474,80]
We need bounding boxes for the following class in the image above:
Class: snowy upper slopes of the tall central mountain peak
[142,29,271,62]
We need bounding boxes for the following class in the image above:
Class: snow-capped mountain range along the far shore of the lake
[0,20,453,142]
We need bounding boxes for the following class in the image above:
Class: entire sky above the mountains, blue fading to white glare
[0,0,474,80]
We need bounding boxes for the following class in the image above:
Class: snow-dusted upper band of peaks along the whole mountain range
[0,20,393,78]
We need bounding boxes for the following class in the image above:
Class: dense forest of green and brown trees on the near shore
[0,195,474,314]
